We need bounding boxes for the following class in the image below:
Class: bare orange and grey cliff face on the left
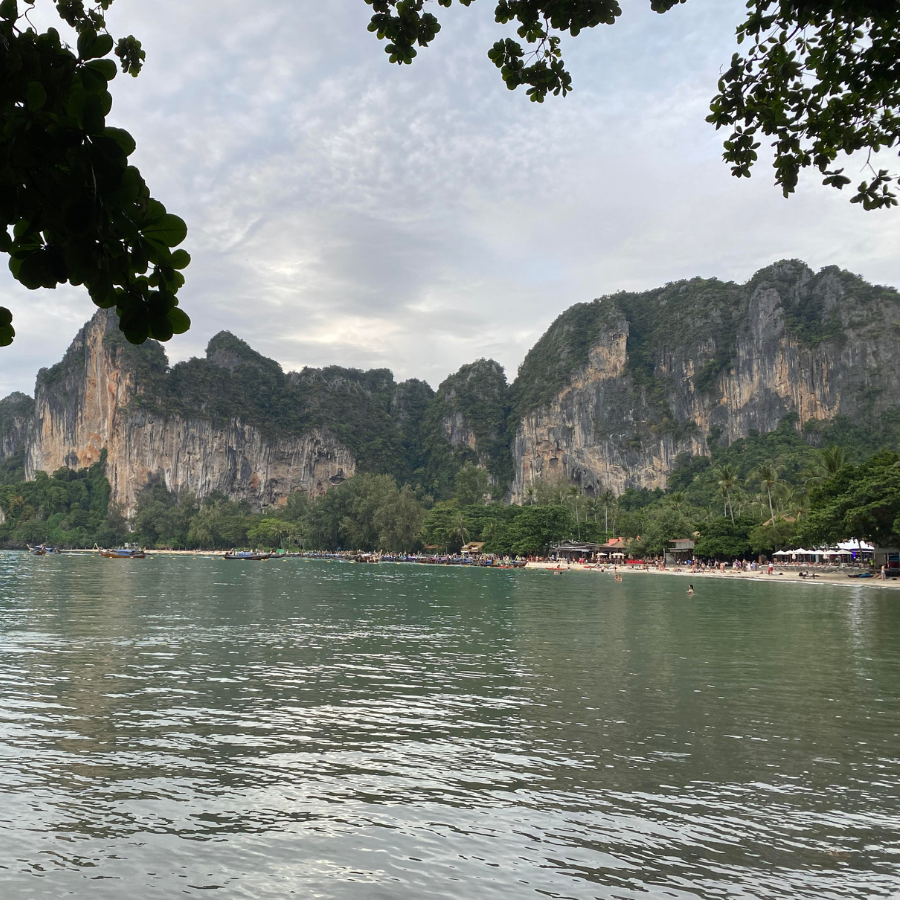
[25,313,356,510]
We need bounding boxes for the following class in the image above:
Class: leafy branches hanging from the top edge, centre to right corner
[366,0,900,209]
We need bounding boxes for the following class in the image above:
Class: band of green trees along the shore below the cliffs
[0,418,900,559]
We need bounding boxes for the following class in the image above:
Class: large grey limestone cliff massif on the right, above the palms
[512,262,900,501]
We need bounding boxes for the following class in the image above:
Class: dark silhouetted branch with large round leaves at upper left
[0,0,190,346]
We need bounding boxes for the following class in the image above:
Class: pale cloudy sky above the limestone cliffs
[0,0,900,394]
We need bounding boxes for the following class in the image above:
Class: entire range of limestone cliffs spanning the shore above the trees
[0,261,900,511]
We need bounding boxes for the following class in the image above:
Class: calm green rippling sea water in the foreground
[0,553,900,900]
